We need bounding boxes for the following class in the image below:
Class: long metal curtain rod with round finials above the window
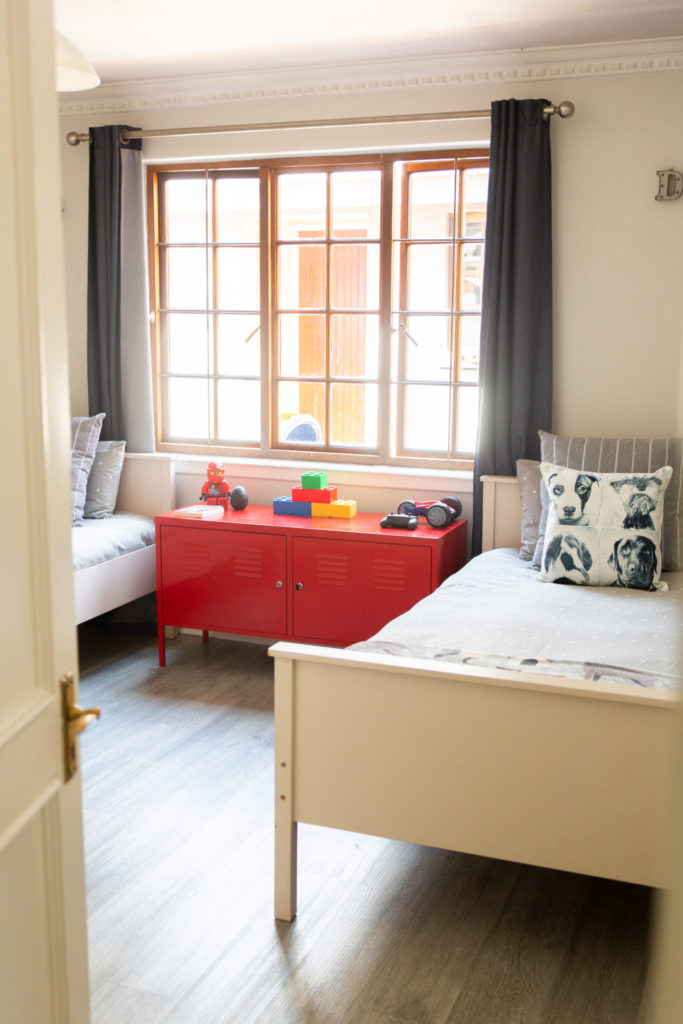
[67,99,574,145]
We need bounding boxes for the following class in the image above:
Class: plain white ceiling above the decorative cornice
[54,0,683,83]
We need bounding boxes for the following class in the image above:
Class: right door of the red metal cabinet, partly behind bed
[292,538,431,645]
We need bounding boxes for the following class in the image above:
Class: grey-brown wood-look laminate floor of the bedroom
[80,623,651,1024]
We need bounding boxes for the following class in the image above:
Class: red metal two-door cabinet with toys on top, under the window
[156,506,467,665]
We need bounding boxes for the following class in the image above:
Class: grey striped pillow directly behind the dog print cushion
[531,430,683,572]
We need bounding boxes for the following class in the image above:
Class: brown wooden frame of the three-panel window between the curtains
[147,148,488,470]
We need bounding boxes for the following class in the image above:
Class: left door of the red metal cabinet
[161,526,287,637]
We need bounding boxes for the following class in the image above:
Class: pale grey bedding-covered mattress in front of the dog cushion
[350,548,683,689]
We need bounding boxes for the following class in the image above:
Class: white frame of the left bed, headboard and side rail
[74,453,175,625]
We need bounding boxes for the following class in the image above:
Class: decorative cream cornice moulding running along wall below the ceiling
[59,37,683,115]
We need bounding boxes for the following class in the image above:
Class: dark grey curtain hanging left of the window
[88,125,155,452]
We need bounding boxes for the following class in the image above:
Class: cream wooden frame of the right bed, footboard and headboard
[270,477,678,921]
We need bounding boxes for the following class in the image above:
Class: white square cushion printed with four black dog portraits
[539,462,673,590]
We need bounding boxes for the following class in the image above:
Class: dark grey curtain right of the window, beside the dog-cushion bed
[472,99,553,555]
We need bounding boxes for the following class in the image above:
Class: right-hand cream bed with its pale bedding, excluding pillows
[270,478,683,920]
